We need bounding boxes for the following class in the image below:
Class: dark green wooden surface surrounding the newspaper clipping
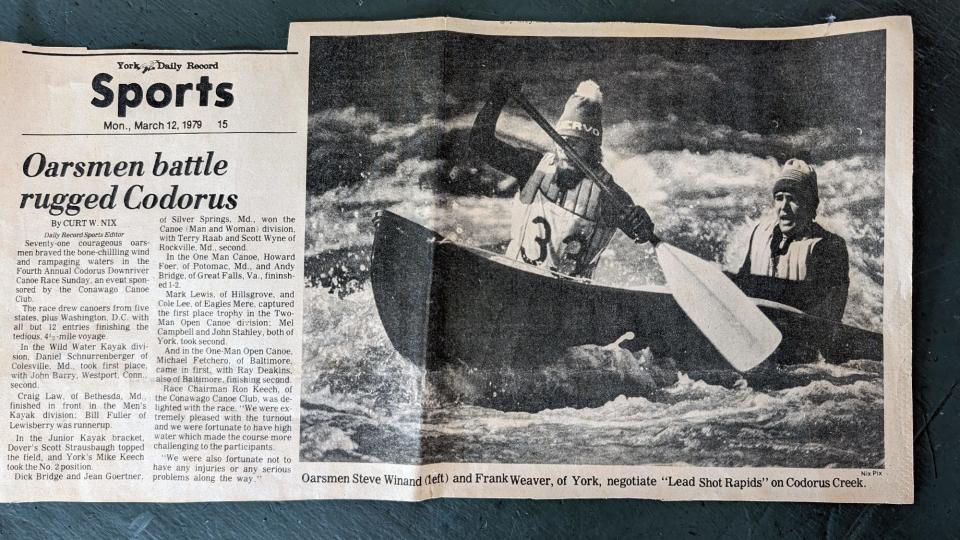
[0,0,960,538]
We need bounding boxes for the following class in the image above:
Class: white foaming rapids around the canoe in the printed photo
[301,141,883,467]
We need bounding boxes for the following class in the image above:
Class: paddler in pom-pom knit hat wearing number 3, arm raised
[470,78,653,278]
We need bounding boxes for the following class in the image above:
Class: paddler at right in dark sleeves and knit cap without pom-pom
[737,159,850,321]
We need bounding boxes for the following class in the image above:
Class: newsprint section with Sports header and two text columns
[0,43,306,502]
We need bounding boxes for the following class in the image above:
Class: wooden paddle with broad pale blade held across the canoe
[511,91,783,371]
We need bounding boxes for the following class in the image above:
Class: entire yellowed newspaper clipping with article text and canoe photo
[0,17,913,503]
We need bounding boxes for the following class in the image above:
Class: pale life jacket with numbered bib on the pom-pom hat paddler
[506,153,616,277]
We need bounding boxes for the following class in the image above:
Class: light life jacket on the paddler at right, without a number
[750,220,826,281]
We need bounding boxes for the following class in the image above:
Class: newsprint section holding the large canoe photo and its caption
[286,17,913,503]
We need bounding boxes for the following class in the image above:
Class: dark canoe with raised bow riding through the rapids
[370,211,883,370]
